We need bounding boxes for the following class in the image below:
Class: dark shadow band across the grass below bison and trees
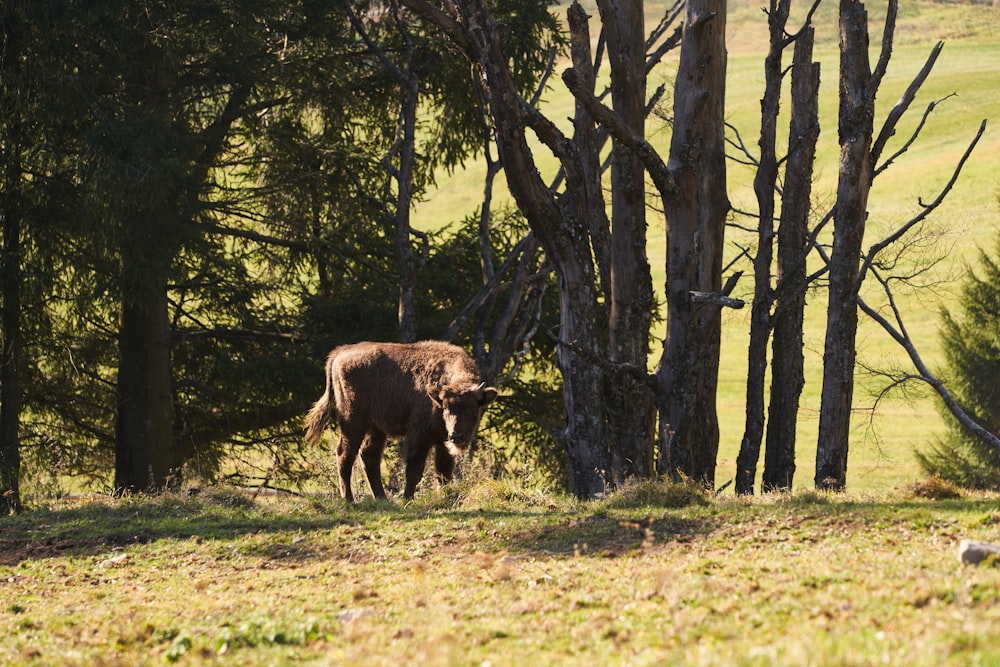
[0,491,1000,566]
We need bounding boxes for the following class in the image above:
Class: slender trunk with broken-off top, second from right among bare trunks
[761,27,820,491]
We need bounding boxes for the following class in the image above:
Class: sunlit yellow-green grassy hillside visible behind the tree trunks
[416,0,1000,489]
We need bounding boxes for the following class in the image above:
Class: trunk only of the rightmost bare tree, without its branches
[815,0,875,490]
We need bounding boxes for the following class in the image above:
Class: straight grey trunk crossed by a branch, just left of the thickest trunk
[596,0,655,485]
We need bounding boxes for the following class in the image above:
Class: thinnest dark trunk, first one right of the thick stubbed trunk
[736,0,790,495]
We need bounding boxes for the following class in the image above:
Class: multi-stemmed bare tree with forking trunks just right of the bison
[405,0,688,497]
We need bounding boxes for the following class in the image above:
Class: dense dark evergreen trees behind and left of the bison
[0,0,557,506]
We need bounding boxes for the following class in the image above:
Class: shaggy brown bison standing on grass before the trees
[306,341,497,501]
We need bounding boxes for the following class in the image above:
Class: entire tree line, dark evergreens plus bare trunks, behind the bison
[0,0,996,509]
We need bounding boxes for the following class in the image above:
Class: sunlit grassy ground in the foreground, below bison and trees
[0,482,1000,667]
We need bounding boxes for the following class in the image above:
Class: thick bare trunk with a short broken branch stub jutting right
[656,0,729,485]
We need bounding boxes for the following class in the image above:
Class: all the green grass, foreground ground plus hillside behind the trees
[7,5,1000,667]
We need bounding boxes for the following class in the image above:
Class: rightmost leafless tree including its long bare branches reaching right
[815,0,1000,490]
